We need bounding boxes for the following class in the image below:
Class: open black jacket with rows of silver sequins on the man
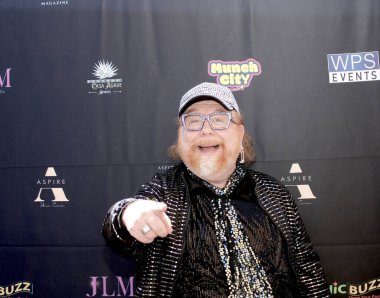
[102,165,330,298]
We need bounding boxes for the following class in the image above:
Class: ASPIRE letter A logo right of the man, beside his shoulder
[281,163,316,203]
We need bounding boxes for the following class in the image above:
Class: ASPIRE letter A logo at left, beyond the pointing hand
[34,167,69,207]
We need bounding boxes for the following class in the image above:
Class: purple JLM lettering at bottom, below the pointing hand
[86,276,135,297]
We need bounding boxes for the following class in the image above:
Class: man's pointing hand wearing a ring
[121,200,173,243]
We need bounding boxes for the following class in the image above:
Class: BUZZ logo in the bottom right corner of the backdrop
[330,278,380,298]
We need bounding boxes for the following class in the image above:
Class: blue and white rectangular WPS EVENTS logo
[327,51,380,83]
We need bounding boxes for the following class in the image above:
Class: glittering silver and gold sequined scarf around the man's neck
[187,165,273,298]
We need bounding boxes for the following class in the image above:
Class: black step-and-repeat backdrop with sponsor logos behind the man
[0,0,380,298]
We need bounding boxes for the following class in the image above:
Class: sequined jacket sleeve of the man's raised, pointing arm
[102,174,163,256]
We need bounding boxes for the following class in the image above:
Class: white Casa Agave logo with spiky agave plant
[87,60,123,95]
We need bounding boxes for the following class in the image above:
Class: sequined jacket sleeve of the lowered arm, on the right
[282,187,331,298]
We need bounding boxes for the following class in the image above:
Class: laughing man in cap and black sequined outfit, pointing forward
[103,83,329,297]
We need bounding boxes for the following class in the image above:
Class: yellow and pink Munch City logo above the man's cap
[208,58,261,91]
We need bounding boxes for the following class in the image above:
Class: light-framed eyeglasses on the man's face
[181,112,236,131]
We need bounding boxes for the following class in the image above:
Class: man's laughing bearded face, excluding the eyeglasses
[178,100,244,187]
